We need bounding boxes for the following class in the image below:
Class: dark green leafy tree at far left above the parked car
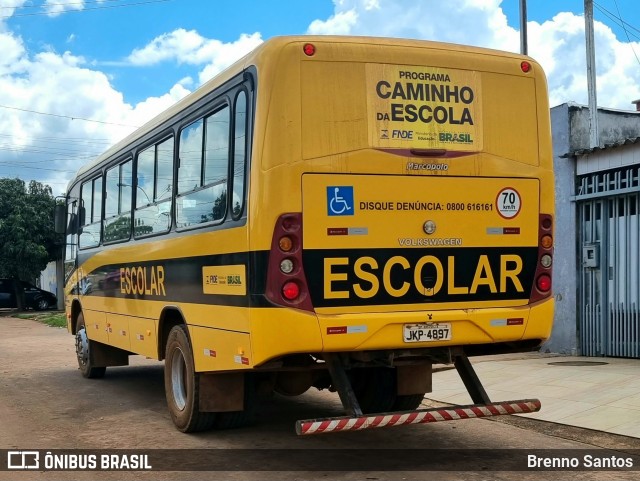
[0,179,58,292]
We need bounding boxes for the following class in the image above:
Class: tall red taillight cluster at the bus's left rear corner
[266,212,313,311]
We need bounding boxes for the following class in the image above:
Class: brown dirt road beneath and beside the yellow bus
[0,317,640,481]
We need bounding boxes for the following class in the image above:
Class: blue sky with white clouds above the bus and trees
[0,0,640,194]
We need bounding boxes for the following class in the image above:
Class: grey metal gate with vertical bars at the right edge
[576,166,640,358]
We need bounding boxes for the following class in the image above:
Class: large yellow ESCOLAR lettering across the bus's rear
[324,254,524,299]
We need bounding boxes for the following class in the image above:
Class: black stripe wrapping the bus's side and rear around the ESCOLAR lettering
[78,247,538,308]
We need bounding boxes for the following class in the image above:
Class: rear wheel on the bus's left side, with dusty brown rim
[164,325,215,433]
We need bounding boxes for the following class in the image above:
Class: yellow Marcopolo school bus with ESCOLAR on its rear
[57,36,554,432]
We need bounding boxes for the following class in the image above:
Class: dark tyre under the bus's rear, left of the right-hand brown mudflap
[351,367,396,414]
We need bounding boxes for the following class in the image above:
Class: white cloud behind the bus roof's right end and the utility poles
[308,0,640,110]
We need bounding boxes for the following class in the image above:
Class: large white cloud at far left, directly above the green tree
[0,43,190,193]
